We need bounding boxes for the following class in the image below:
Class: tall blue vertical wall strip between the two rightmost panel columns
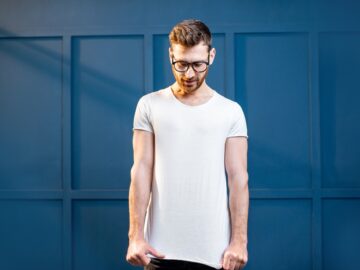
[309,31,322,270]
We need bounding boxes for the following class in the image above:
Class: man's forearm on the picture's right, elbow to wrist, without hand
[229,174,249,245]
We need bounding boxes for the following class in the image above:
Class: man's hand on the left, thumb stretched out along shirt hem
[126,239,165,266]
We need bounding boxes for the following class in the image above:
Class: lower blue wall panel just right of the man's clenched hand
[247,200,312,270]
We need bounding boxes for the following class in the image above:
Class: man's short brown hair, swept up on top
[169,19,211,51]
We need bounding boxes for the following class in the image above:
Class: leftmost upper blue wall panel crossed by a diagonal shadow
[0,38,62,189]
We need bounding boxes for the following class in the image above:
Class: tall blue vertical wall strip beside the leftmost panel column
[62,35,71,270]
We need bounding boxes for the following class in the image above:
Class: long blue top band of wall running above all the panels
[0,0,318,32]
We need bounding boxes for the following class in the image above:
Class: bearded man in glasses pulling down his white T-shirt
[126,20,249,270]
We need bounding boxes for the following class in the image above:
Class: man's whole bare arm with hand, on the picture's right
[222,137,249,270]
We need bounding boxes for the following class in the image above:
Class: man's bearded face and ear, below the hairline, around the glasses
[169,43,215,93]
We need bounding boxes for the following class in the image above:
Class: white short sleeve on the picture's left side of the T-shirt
[133,95,154,132]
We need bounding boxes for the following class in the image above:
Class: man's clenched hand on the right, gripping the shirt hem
[221,243,248,270]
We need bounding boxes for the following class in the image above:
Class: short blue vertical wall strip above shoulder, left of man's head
[144,33,154,93]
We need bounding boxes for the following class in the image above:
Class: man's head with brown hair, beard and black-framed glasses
[169,20,215,93]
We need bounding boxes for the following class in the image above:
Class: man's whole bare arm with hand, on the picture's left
[126,130,164,266]
